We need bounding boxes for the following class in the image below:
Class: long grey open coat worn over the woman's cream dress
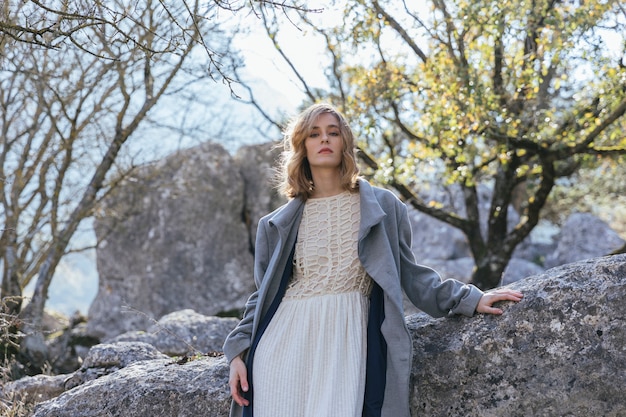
[224,180,482,417]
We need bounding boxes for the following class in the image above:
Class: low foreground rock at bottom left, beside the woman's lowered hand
[33,357,230,417]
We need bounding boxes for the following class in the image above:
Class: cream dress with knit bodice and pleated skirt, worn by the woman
[253,192,372,417]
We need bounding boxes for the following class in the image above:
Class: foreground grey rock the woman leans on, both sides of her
[12,255,626,417]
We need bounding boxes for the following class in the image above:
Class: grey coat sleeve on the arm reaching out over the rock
[397,203,483,317]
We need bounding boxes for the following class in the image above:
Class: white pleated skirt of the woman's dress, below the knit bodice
[253,292,369,417]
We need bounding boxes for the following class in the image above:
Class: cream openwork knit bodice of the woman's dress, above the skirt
[285,191,372,299]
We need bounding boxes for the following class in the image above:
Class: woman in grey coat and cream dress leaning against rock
[224,104,522,417]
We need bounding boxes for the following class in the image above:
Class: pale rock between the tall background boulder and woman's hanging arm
[109,309,239,356]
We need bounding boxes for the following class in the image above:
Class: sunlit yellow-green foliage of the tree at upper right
[344,1,626,184]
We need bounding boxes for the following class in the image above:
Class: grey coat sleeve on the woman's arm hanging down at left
[223,219,269,362]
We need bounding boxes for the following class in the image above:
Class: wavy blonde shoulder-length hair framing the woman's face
[278,103,359,201]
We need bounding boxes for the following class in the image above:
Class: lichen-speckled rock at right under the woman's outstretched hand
[408,255,626,417]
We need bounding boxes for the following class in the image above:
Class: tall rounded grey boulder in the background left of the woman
[88,143,253,339]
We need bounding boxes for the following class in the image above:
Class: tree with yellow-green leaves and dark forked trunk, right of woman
[251,0,626,289]
